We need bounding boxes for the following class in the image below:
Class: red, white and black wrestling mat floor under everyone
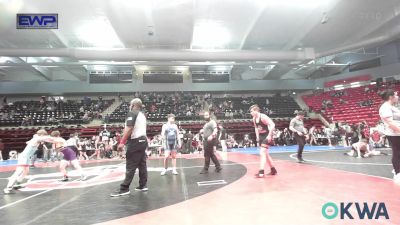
[0,146,400,225]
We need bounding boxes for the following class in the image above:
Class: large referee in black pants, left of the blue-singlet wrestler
[110,98,148,197]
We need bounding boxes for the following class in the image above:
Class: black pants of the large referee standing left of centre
[120,137,147,191]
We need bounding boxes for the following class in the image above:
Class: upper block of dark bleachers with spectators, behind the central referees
[105,92,300,123]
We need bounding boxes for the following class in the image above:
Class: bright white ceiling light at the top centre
[192,20,231,49]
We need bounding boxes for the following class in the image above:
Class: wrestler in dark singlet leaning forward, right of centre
[250,105,278,178]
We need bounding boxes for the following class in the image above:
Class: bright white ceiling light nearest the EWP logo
[76,17,124,48]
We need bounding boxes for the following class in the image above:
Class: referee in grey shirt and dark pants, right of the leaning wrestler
[289,111,307,163]
